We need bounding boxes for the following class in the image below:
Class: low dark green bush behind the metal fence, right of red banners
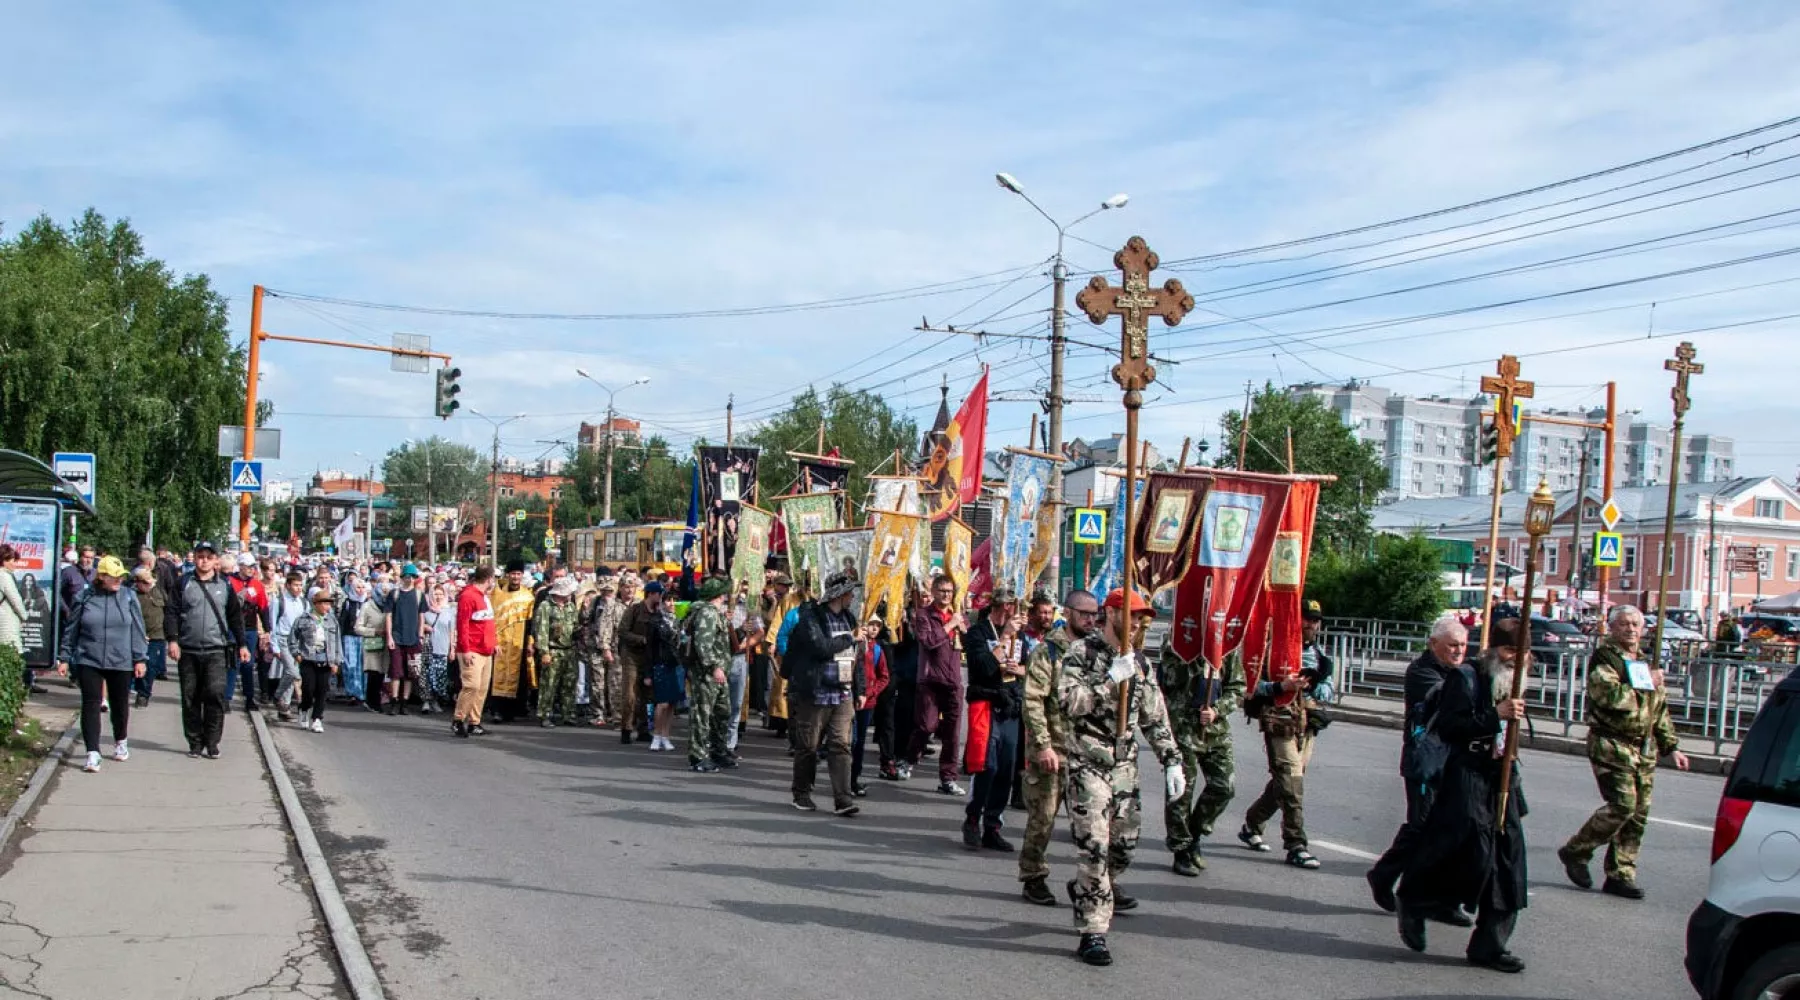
[1307,534,1444,622]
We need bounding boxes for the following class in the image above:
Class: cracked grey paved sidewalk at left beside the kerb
[0,676,349,1000]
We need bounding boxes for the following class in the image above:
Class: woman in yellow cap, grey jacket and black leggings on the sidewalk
[56,556,148,773]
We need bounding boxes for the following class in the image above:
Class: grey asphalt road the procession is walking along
[277,710,1719,1000]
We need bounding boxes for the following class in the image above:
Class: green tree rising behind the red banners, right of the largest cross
[1217,383,1388,556]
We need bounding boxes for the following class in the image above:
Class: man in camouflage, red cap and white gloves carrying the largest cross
[1057,590,1186,966]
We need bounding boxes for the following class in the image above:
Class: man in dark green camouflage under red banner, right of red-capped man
[1161,642,1244,878]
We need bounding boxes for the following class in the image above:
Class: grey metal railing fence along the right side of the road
[1321,619,1795,752]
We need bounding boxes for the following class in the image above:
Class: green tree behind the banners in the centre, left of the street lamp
[751,385,920,504]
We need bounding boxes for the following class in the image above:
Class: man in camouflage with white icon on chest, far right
[1557,604,1688,899]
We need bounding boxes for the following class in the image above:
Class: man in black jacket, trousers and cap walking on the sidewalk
[162,541,250,759]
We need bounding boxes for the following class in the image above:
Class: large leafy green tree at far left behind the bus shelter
[0,209,245,552]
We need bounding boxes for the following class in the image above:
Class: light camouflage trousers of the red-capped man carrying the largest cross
[1066,757,1143,933]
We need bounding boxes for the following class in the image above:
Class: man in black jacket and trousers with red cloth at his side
[963,585,1024,854]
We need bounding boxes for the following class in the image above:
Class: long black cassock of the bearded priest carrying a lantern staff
[1399,665,1528,955]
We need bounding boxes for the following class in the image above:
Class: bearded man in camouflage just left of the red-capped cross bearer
[1019,590,1100,906]
